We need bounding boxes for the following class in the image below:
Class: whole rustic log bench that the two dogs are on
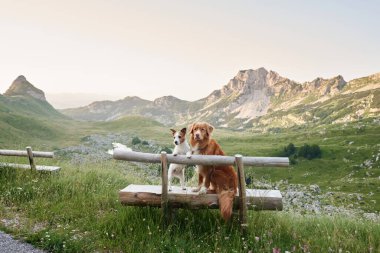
[113,149,289,229]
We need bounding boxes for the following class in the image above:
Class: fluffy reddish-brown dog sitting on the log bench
[189,122,237,221]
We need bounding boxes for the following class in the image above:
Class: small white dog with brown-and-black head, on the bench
[168,128,190,191]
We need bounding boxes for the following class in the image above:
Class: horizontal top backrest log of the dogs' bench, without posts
[113,148,289,167]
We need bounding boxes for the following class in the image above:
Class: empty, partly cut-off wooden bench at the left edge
[0,147,61,172]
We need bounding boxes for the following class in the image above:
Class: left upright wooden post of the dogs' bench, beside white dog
[161,151,169,228]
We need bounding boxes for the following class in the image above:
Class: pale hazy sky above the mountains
[0,0,380,106]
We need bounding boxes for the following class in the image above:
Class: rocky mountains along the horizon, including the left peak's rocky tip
[4,68,380,131]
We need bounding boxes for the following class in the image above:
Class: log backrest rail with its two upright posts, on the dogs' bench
[113,149,289,230]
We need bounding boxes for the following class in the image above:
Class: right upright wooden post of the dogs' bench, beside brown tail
[235,155,248,233]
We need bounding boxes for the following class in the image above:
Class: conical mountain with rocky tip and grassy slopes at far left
[0,76,69,146]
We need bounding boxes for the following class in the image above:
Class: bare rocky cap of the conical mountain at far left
[4,75,46,101]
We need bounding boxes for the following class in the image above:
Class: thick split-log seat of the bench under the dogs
[119,184,282,211]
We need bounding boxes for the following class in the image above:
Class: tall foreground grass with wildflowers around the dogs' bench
[0,161,380,252]
